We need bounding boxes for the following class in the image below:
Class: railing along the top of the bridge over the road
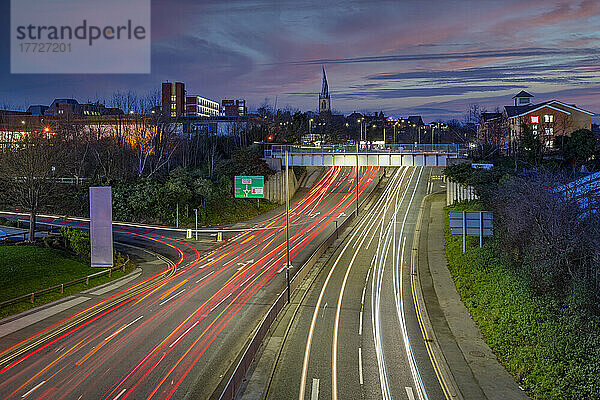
[265,143,459,158]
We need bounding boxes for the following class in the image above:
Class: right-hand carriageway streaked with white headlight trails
[266,167,451,400]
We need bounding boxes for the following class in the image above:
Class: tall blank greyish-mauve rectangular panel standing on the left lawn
[90,186,113,268]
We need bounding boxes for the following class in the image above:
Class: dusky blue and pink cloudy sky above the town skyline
[0,0,600,122]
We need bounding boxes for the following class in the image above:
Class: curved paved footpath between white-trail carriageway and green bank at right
[418,194,528,400]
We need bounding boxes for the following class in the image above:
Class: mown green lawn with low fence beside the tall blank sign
[0,246,135,318]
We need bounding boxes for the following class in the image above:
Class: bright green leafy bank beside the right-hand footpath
[445,202,600,399]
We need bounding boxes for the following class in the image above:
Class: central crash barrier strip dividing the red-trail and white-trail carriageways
[219,170,382,400]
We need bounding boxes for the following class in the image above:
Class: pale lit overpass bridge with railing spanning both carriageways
[265,144,461,167]
